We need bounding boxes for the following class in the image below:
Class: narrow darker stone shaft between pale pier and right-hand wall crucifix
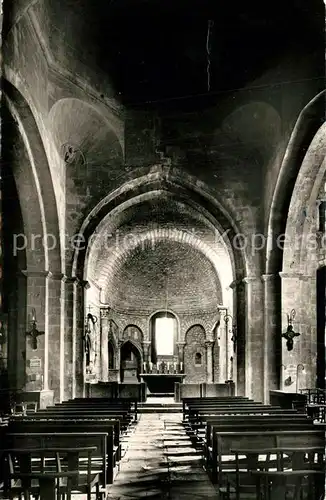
[261,274,281,404]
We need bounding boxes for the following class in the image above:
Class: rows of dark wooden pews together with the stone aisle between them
[1,391,325,500]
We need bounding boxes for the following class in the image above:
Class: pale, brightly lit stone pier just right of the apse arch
[242,276,264,401]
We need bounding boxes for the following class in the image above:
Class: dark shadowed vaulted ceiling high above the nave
[7,0,324,109]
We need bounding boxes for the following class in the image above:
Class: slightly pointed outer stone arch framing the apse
[72,166,247,392]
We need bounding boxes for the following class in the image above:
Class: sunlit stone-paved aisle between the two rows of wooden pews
[107,413,217,500]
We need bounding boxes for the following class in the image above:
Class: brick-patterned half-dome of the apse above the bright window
[104,237,221,313]
